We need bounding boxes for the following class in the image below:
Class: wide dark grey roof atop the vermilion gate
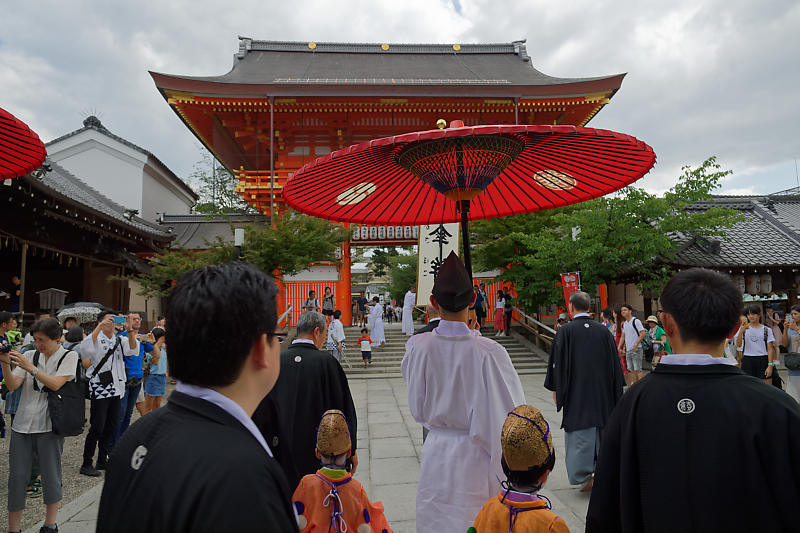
[152,37,624,91]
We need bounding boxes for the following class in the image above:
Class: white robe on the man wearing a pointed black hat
[402,320,525,533]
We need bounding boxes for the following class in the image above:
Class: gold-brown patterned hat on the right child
[500,405,554,472]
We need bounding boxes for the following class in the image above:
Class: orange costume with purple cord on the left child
[292,468,392,533]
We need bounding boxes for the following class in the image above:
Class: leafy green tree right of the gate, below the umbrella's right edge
[475,157,741,309]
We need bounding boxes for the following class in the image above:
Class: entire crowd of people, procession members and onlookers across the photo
[0,254,800,533]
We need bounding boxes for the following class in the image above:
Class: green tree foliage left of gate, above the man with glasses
[127,212,349,296]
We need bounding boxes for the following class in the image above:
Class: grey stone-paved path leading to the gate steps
[28,375,589,533]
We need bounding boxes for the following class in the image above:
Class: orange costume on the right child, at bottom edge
[467,492,569,533]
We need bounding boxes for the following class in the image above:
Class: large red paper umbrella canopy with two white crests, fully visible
[284,125,656,225]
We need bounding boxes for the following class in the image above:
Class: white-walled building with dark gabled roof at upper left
[45,116,198,222]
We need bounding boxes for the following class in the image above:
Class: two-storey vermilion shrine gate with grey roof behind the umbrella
[150,37,624,324]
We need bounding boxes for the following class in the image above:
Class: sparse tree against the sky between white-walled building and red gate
[187,150,256,215]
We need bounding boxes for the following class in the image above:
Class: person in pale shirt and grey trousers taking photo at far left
[0,318,78,531]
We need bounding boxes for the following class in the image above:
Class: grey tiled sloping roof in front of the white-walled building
[31,162,173,241]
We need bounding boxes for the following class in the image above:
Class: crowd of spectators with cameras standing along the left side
[0,311,167,533]
